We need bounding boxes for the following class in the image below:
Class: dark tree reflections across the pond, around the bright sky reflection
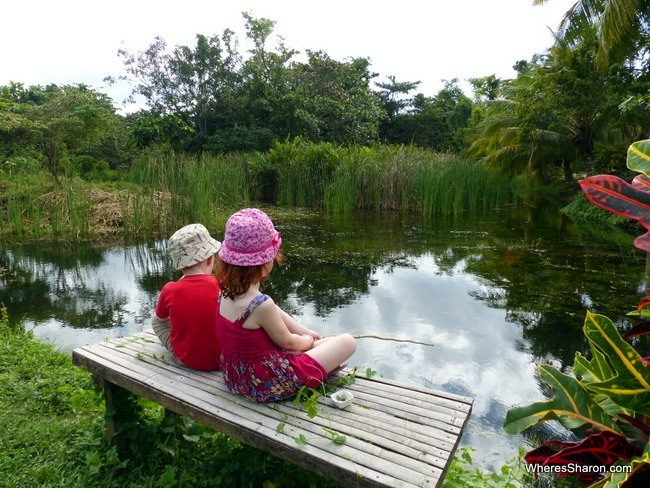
[0,207,645,365]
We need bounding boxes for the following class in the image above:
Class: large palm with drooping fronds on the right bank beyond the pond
[469,26,630,183]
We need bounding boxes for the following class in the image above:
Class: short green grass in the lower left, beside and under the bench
[0,309,337,488]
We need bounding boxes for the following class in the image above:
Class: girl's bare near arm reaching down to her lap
[250,299,316,352]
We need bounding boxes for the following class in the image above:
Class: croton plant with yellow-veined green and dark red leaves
[504,140,650,488]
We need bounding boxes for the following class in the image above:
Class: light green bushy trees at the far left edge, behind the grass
[0,84,132,183]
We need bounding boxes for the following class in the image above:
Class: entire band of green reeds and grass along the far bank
[0,139,515,240]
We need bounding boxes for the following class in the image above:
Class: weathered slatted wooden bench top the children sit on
[72,332,473,488]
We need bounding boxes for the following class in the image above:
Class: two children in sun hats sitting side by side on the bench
[152,212,356,402]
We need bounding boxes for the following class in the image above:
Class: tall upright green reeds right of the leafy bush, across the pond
[312,146,514,217]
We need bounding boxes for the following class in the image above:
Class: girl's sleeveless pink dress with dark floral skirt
[217,294,327,402]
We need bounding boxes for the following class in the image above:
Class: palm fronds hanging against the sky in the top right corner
[533,0,650,70]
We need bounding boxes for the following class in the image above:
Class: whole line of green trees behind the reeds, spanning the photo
[0,8,650,198]
